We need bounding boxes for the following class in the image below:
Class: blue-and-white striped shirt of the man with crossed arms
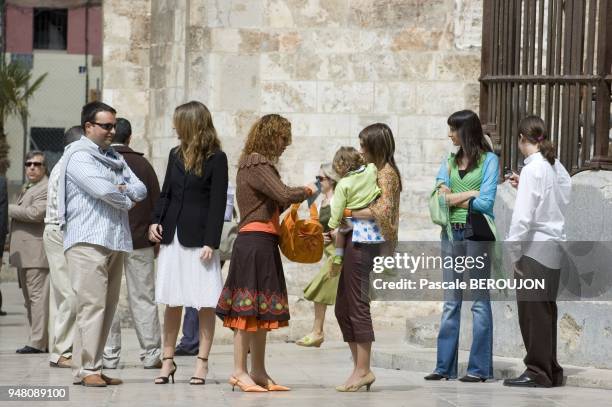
[64,139,147,252]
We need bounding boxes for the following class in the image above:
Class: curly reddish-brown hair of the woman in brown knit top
[241,114,291,162]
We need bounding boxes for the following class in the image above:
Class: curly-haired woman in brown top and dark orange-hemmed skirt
[217,114,314,392]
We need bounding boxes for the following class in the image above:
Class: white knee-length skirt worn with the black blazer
[155,230,223,309]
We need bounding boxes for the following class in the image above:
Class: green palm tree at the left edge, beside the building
[0,58,47,175]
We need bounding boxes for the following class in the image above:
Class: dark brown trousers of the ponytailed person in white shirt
[514,256,563,386]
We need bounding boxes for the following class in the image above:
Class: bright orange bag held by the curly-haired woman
[280,203,323,263]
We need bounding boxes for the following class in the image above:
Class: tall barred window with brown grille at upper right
[480,0,612,173]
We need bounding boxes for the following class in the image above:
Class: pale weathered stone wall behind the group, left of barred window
[104,0,482,234]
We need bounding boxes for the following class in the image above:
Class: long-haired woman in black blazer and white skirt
[149,102,227,384]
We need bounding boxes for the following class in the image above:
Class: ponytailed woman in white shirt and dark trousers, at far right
[504,116,571,387]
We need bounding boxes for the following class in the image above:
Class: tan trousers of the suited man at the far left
[17,268,49,351]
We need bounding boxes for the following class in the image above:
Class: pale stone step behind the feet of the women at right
[372,344,612,390]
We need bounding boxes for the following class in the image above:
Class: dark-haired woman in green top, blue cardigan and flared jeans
[425,110,499,382]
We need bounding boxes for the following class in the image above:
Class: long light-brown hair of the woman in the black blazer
[173,101,221,177]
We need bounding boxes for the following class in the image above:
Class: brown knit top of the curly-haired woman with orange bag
[236,153,310,229]
